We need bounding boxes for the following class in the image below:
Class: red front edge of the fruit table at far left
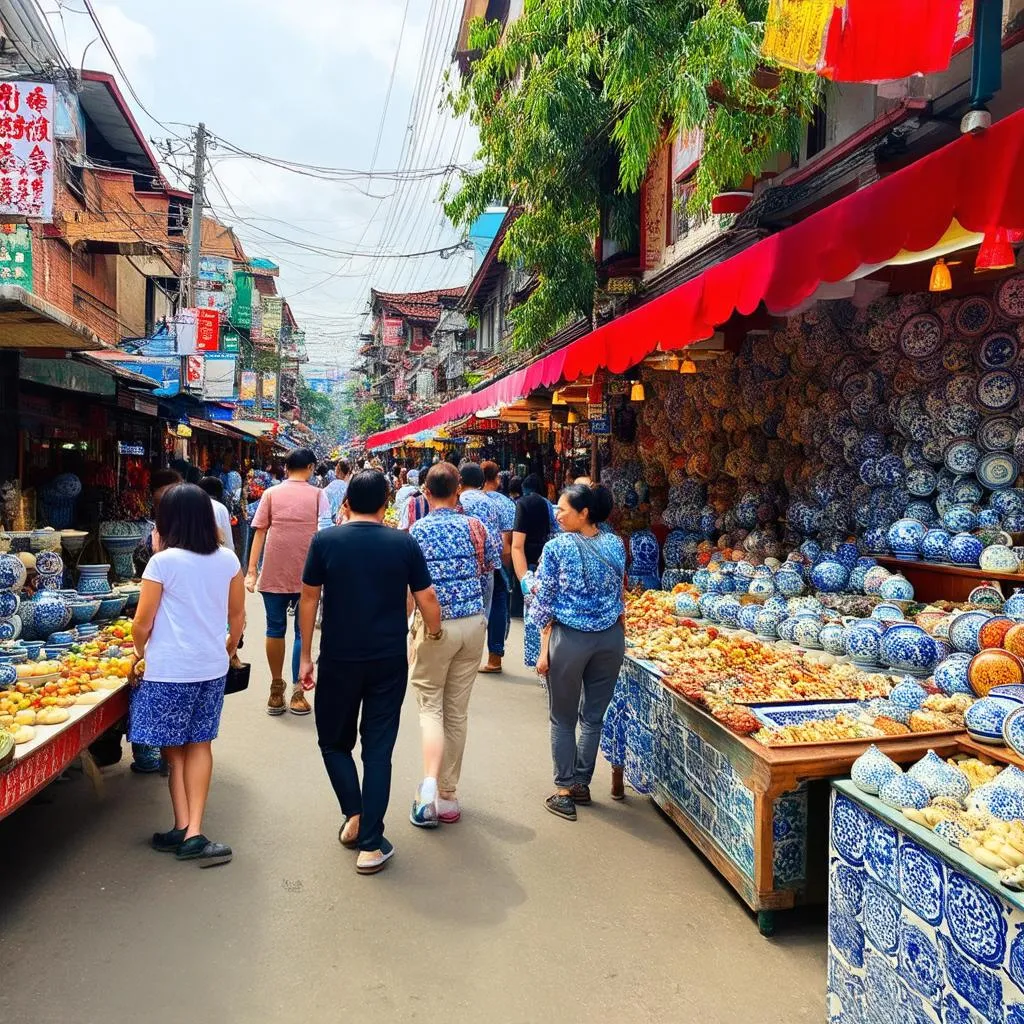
[0,686,128,818]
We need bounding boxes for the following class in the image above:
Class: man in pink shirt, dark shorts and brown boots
[246,449,331,715]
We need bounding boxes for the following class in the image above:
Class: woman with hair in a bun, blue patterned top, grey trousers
[528,483,626,821]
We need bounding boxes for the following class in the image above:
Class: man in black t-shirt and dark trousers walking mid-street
[299,469,442,874]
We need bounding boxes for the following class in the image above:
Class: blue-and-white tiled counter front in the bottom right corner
[827,781,1024,1024]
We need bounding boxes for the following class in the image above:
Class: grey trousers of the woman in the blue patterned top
[548,623,626,788]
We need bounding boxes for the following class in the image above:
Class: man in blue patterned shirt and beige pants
[410,462,501,828]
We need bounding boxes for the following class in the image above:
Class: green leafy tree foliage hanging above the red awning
[442,0,818,347]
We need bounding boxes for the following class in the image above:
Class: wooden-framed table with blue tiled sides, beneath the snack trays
[604,655,962,937]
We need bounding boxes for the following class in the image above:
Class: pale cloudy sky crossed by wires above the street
[41,0,473,360]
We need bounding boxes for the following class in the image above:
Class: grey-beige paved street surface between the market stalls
[0,598,825,1024]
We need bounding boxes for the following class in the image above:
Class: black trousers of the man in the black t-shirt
[313,654,409,850]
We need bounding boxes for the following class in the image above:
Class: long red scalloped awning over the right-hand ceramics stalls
[367,111,1024,447]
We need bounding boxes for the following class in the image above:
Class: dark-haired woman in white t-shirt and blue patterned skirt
[129,483,245,867]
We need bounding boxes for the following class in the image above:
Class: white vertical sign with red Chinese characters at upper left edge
[0,82,53,220]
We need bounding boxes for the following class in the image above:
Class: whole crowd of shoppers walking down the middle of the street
[129,449,626,874]
